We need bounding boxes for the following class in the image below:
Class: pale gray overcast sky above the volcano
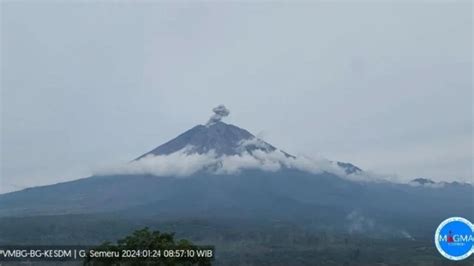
[0,1,473,192]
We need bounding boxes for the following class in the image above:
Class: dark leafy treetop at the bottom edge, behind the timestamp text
[84,228,213,266]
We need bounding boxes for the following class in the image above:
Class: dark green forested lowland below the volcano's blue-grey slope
[0,215,474,266]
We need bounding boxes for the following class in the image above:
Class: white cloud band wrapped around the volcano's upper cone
[96,140,398,185]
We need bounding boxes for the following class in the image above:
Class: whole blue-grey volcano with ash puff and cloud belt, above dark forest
[0,106,474,239]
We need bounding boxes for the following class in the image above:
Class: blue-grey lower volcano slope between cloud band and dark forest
[0,170,474,237]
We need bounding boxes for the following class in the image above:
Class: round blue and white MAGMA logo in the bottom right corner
[435,217,474,260]
